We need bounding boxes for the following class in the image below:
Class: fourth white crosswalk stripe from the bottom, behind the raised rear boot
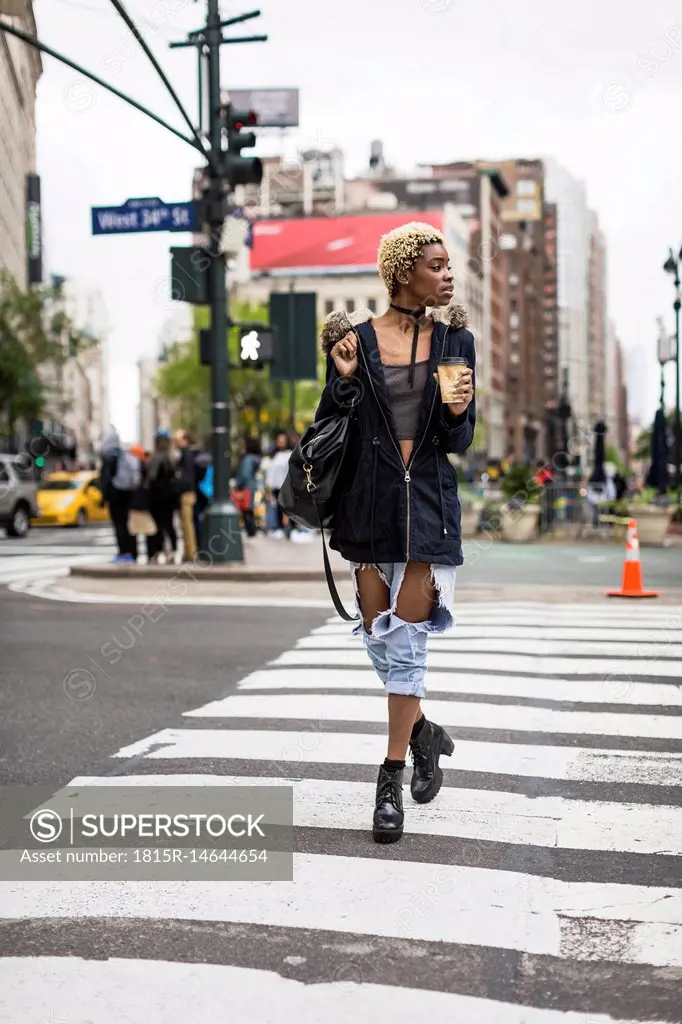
[114,723,682,785]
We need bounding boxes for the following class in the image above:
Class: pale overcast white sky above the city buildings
[35,0,682,440]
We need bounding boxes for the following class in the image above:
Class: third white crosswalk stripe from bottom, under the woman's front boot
[67,774,682,856]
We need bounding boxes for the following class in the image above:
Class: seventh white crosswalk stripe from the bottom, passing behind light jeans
[270,644,682,679]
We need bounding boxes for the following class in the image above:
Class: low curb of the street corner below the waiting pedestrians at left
[69,562,326,583]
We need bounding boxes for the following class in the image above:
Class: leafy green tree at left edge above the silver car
[0,269,73,440]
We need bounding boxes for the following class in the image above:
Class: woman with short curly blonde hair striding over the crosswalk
[315,222,476,842]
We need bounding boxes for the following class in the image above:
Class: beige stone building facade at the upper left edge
[0,3,42,288]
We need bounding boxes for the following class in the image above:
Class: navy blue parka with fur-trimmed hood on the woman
[315,306,476,565]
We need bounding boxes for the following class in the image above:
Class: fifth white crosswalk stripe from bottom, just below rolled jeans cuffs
[184,692,682,739]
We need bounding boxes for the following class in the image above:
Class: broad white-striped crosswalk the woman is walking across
[0,604,682,1024]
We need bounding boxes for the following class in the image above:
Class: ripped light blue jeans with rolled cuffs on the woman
[350,562,456,697]
